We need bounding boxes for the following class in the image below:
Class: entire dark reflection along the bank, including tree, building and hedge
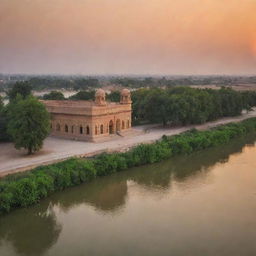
[0,134,255,256]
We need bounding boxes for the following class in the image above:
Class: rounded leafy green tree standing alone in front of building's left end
[7,96,50,154]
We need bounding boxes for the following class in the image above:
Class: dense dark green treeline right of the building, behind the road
[132,87,256,125]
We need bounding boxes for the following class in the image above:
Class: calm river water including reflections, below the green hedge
[0,138,256,256]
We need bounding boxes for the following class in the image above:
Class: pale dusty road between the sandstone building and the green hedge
[0,109,256,177]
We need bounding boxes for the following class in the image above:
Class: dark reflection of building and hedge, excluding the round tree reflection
[42,136,255,214]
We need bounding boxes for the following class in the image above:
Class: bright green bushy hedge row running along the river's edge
[0,118,256,213]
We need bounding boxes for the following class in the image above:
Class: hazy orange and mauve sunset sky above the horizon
[0,0,256,75]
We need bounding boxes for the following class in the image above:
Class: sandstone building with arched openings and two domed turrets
[42,89,132,141]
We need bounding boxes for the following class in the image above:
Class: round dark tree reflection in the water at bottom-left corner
[0,204,61,256]
